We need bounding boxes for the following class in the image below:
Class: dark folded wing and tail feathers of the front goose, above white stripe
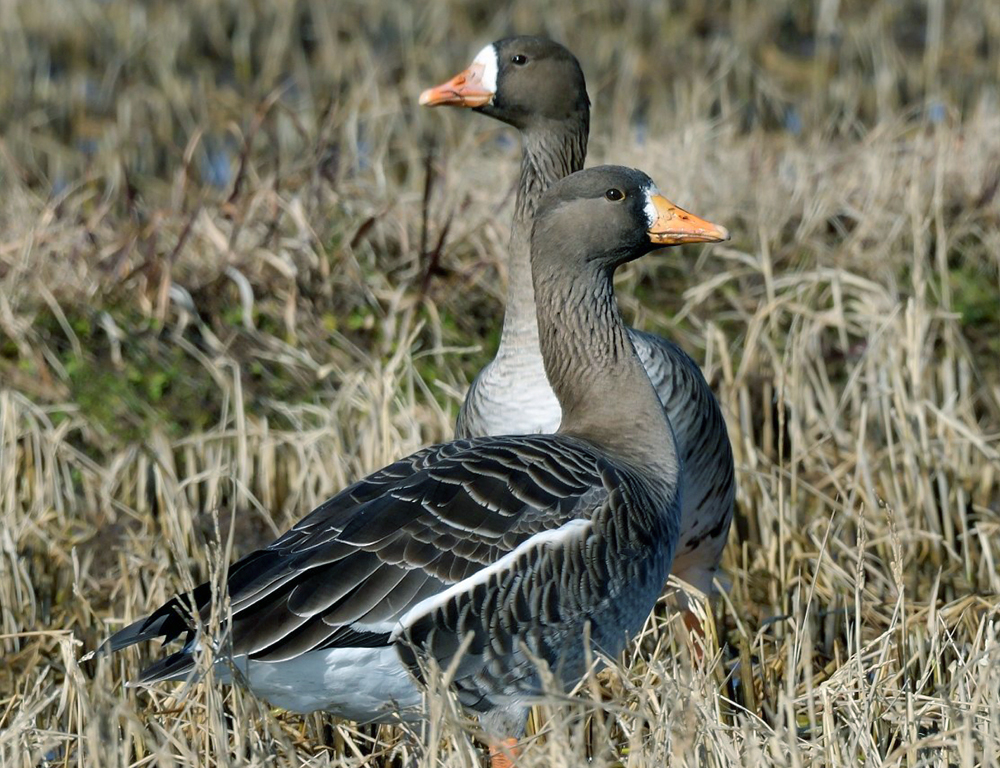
[107,435,607,680]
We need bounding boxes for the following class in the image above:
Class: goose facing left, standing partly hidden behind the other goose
[420,36,736,616]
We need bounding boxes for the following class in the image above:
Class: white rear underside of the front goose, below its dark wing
[220,647,421,723]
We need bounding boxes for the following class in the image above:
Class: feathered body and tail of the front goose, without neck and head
[107,435,677,733]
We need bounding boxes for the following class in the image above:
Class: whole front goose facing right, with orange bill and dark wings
[95,166,728,765]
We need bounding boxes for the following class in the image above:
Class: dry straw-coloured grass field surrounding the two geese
[0,0,1000,768]
